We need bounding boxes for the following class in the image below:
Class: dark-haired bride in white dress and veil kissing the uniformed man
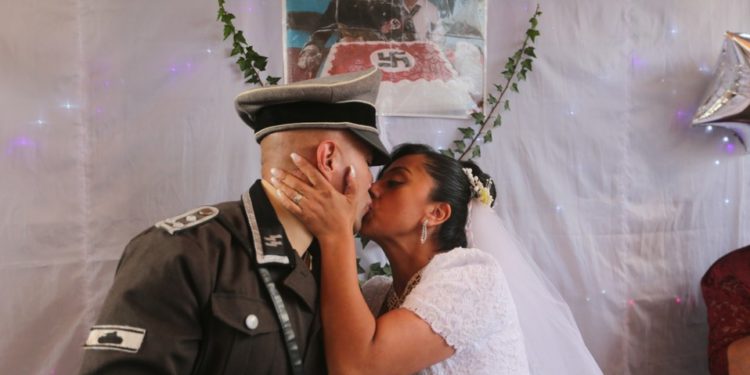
[272,145,601,374]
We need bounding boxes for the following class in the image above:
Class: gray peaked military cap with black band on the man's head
[234,68,389,165]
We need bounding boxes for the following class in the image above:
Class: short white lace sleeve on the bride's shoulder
[401,248,518,352]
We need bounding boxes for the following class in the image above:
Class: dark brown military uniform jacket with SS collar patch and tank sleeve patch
[81,181,326,375]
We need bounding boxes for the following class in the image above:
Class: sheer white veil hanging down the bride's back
[466,200,602,375]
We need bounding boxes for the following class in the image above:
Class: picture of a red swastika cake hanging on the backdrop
[282,0,486,118]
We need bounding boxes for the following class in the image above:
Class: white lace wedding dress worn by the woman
[362,248,529,375]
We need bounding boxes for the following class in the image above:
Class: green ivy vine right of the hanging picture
[441,4,542,160]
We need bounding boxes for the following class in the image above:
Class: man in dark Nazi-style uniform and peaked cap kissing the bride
[81,69,388,375]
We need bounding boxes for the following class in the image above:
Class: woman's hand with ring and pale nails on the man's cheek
[271,154,359,244]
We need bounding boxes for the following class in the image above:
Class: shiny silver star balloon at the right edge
[693,32,750,151]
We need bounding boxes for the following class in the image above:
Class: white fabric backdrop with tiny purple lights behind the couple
[0,0,750,374]
